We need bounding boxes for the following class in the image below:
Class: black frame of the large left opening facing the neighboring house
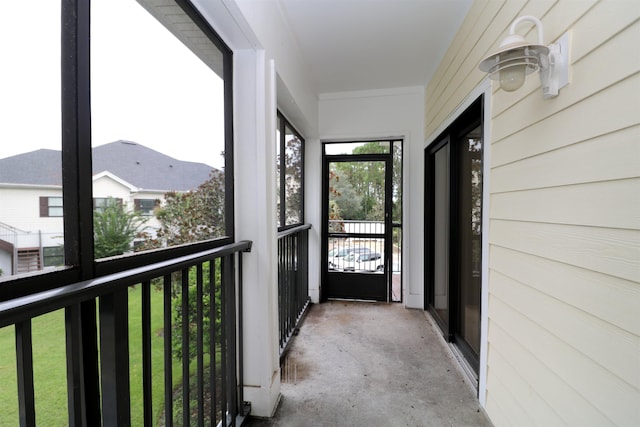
[0,0,235,301]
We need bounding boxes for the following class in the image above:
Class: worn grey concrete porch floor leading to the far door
[245,301,491,427]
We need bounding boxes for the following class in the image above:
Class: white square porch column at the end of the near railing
[234,50,280,417]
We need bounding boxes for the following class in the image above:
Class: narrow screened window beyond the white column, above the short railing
[276,113,304,229]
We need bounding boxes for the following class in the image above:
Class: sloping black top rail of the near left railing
[0,240,252,328]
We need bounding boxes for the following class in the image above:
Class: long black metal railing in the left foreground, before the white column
[0,242,251,426]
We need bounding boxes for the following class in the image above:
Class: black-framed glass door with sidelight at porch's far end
[322,141,401,301]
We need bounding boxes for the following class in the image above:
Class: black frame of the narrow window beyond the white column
[277,110,305,231]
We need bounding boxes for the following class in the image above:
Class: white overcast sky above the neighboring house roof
[0,0,224,168]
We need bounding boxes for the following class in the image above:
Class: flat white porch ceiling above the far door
[280,0,472,93]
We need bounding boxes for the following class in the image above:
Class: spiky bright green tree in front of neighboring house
[93,198,147,259]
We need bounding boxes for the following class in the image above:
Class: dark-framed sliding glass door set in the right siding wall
[425,99,483,373]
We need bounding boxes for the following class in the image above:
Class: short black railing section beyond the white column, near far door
[278,224,311,355]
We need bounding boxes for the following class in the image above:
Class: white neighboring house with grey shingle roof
[0,141,213,275]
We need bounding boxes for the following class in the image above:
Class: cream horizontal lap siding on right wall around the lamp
[425,0,640,427]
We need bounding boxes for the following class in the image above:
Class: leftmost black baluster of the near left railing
[15,319,36,427]
